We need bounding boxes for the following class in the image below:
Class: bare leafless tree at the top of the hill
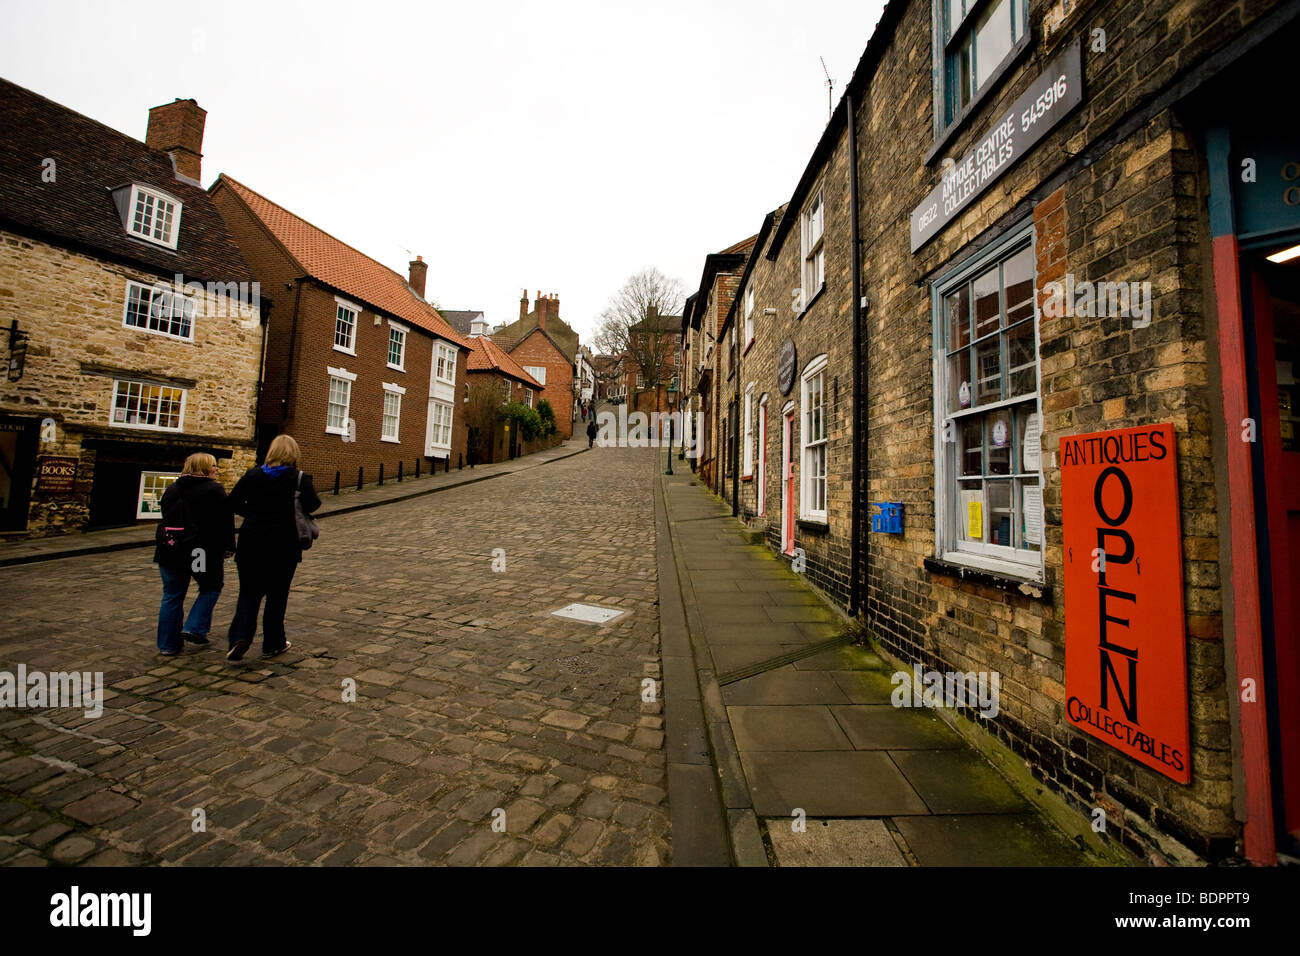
[595,265,685,408]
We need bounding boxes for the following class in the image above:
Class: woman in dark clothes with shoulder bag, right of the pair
[226,434,321,661]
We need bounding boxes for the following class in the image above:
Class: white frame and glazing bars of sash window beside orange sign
[932,222,1047,584]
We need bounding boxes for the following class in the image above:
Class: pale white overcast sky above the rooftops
[0,0,884,341]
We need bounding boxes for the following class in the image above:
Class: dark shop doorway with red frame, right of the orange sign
[1242,250,1300,856]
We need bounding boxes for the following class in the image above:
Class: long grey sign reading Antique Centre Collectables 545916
[911,40,1083,252]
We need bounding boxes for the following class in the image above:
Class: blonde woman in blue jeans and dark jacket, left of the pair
[153,453,235,657]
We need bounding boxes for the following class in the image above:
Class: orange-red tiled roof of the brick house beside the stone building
[212,173,469,349]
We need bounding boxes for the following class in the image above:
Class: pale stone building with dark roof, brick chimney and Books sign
[0,81,261,536]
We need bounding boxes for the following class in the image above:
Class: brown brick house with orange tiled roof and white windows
[209,176,469,486]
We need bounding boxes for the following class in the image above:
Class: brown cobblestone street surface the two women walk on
[0,449,670,865]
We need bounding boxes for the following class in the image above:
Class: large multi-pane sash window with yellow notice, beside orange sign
[935,226,1043,580]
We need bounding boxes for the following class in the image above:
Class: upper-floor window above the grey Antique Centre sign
[933,0,1030,133]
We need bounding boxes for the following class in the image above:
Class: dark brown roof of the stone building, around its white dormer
[0,79,252,282]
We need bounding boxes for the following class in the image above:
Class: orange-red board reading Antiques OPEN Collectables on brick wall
[1061,424,1192,783]
